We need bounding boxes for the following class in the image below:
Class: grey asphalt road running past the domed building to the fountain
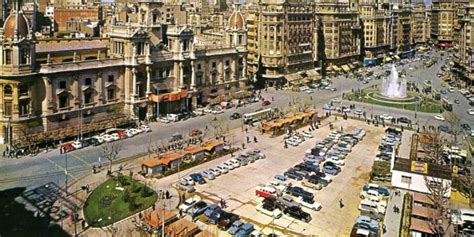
[0,49,474,190]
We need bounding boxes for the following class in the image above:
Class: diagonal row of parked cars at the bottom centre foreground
[178,196,262,237]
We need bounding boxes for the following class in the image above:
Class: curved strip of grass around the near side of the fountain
[346,90,443,113]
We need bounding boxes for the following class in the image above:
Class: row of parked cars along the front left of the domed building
[61,124,151,152]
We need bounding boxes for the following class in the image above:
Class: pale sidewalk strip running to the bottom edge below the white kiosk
[382,190,405,237]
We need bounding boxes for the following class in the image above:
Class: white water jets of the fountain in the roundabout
[381,64,407,99]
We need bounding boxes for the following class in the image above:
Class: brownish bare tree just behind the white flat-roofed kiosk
[419,131,446,164]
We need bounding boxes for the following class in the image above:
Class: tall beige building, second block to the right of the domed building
[316,0,362,73]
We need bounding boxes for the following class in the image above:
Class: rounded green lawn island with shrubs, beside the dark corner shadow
[84,175,158,227]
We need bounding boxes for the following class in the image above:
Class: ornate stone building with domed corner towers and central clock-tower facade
[0,0,247,146]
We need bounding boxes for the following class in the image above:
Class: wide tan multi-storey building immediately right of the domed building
[249,0,317,85]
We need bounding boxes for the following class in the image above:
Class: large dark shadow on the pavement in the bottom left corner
[0,186,73,236]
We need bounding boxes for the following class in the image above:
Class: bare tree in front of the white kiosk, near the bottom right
[424,176,451,236]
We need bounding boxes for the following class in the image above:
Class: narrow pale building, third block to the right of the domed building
[357,0,390,66]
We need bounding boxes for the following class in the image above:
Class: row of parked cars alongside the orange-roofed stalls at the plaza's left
[177,148,266,193]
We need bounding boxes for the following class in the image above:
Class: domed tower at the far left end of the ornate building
[0,0,35,75]
